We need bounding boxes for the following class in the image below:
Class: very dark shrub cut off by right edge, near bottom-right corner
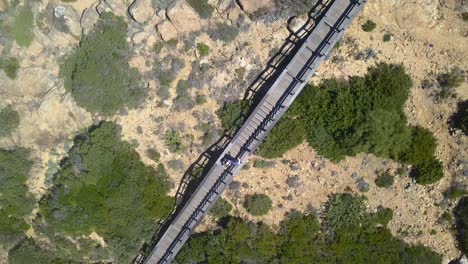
[453,197,468,255]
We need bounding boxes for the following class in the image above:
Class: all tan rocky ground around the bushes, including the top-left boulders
[0,0,468,260]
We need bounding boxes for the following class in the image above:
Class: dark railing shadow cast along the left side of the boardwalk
[134,0,333,263]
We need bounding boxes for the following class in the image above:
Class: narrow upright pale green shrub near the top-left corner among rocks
[13,5,34,47]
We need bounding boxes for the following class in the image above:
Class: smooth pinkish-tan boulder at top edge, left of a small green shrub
[166,1,203,33]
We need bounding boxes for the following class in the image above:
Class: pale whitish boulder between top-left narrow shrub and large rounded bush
[54,5,81,37]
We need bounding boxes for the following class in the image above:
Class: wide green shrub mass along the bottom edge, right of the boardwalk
[176,195,442,264]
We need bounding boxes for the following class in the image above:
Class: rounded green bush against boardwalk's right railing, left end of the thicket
[257,117,306,159]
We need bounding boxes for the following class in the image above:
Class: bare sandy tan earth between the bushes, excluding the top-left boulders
[0,0,468,262]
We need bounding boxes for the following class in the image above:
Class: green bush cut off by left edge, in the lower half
[0,148,35,246]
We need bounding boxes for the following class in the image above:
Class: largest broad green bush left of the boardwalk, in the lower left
[40,122,173,263]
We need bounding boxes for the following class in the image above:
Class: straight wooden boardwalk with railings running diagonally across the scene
[145,0,366,264]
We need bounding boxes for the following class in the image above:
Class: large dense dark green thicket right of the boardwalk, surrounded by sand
[259,64,443,184]
